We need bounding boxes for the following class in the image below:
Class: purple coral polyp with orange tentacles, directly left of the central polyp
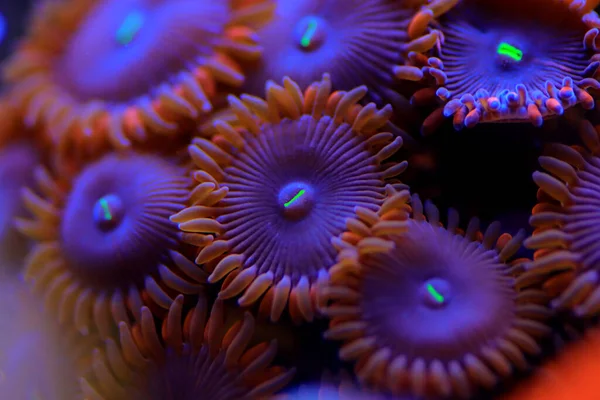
[17,152,206,337]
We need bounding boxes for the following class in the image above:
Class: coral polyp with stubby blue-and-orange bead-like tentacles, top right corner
[395,0,600,130]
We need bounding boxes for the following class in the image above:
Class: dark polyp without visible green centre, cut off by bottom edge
[81,296,295,400]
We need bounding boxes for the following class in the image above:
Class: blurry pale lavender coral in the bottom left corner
[0,277,91,400]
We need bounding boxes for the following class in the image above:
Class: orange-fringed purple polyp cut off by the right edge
[524,117,600,316]
